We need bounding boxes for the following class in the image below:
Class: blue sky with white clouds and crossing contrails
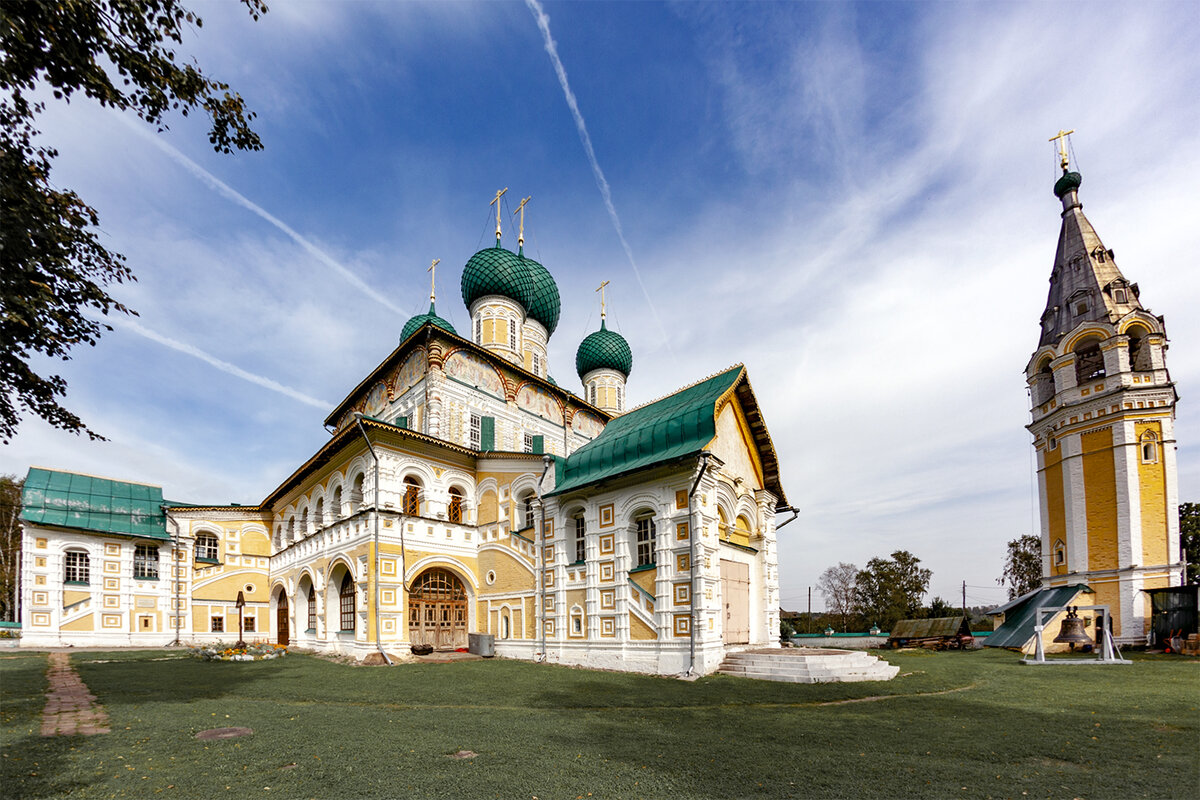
[0,0,1200,610]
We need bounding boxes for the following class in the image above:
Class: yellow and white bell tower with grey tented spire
[1025,131,1182,643]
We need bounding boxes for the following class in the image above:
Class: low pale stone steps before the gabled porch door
[716,648,900,684]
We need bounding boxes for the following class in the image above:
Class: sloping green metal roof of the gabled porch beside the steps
[551,365,744,495]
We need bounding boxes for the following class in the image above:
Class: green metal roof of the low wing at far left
[20,467,169,540]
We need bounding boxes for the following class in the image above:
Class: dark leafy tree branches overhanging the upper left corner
[0,0,266,443]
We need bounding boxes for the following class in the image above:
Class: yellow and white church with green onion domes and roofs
[22,194,792,674]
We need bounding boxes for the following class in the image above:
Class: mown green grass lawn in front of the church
[0,650,1200,800]
